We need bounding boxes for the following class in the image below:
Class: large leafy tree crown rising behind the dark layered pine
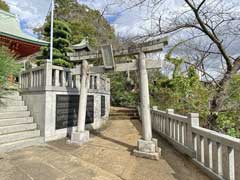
[37,0,115,47]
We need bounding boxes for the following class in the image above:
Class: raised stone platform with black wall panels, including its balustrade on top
[19,62,110,141]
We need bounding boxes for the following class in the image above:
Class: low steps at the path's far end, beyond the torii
[110,107,139,121]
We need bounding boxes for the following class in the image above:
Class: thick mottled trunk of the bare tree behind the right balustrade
[206,58,240,130]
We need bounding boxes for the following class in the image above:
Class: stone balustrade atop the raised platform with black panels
[19,63,110,92]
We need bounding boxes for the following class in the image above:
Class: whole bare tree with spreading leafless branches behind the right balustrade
[112,0,240,128]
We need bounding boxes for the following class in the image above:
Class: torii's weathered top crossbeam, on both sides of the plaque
[68,37,168,62]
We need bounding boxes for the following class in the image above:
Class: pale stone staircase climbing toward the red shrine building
[0,92,44,153]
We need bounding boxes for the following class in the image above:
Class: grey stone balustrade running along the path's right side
[151,107,240,180]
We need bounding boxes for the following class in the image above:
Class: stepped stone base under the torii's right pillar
[133,139,161,160]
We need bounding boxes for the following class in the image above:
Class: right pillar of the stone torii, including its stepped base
[133,52,161,160]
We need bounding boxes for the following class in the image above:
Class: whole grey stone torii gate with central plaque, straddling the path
[69,37,168,159]
